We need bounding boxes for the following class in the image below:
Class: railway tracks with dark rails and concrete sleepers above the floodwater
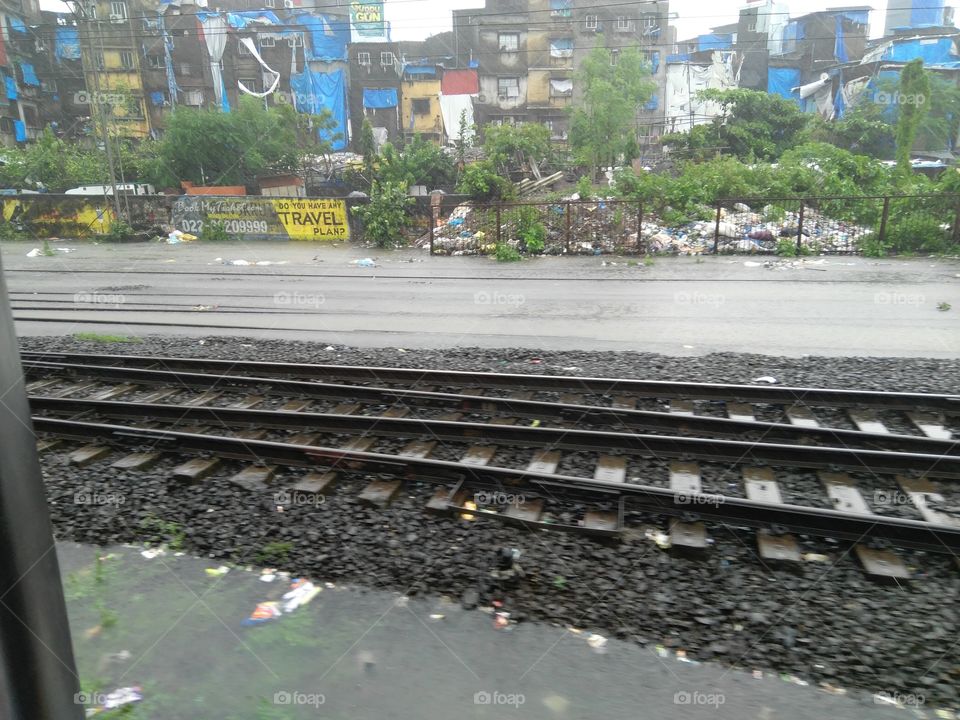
[22,353,960,577]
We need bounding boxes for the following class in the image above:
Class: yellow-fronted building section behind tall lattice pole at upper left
[75,0,151,139]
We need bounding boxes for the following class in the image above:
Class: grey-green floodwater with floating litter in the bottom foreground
[58,543,904,720]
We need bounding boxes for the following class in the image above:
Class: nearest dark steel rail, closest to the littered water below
[34,417,960,554]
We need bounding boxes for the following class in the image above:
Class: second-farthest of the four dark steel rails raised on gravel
[18,362,960,455]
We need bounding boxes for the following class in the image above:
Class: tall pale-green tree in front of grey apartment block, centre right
[570,48,656,170]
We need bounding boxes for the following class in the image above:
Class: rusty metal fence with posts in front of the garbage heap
[421,194,960,255]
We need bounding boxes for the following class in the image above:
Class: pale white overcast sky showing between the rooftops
[386,0,960,40]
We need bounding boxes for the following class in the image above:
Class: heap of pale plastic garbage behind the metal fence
[417,201,871,255]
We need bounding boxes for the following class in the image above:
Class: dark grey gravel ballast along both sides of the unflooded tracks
[21,337,960,707]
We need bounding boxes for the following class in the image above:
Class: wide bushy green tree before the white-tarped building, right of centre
[663,89,809,161]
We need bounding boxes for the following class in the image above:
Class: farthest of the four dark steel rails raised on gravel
[21,352,960,413]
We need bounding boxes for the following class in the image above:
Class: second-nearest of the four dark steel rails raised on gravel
[31,397,960,478]
